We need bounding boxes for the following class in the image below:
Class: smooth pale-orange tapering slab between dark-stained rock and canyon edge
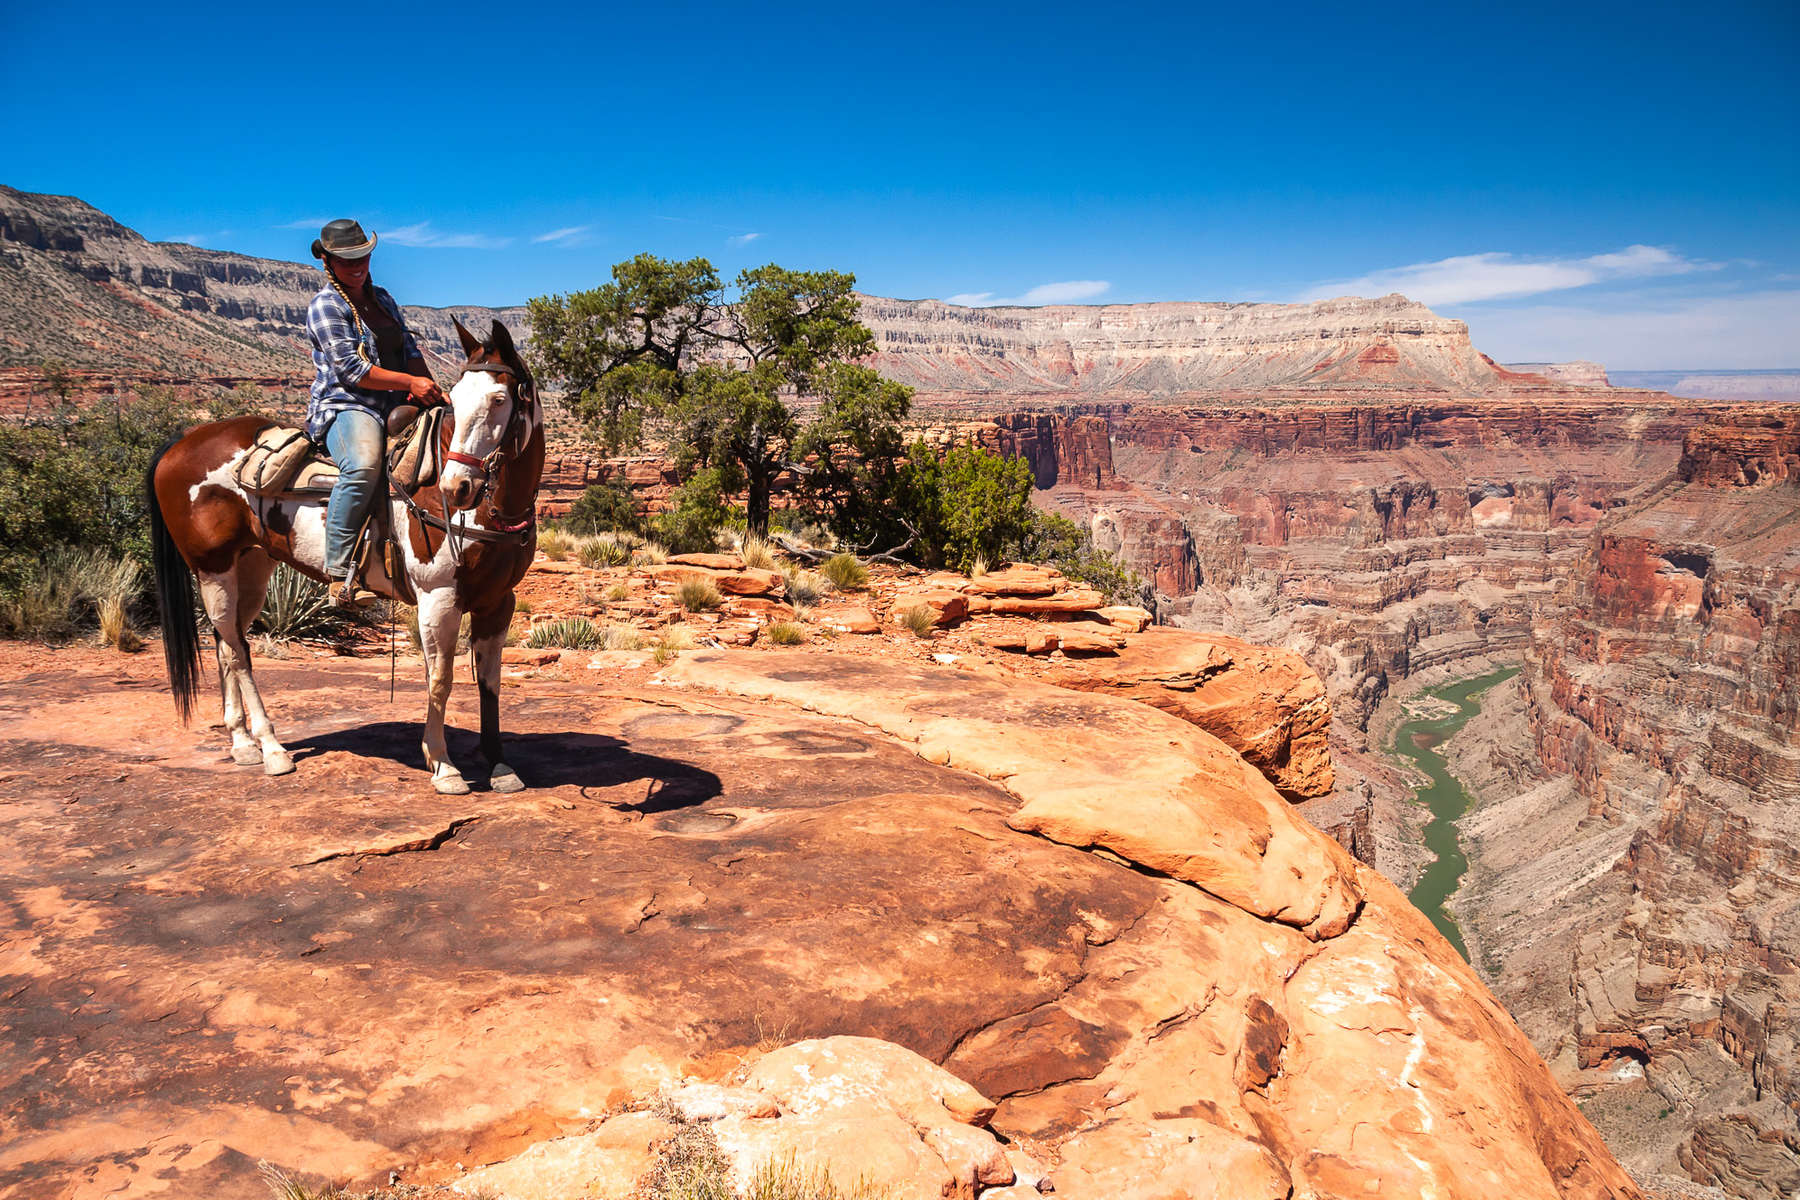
[661,651,1359,937]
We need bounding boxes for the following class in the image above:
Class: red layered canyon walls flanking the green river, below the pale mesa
[970,401,1800,1196]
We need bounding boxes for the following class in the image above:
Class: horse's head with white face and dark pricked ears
[437,320,540,511]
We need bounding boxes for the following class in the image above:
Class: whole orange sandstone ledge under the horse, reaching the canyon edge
[0,550,1636,1200]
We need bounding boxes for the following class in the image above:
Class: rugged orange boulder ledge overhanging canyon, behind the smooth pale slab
[1046,628,1336,801]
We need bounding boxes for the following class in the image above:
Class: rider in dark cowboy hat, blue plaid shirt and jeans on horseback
[306,219,445,608]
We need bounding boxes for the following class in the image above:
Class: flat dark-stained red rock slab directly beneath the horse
[0,648,1156,1200]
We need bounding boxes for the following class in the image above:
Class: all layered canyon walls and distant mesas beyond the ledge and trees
[0,189,1800,1198]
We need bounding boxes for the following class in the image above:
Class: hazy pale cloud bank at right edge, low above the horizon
[1451,290,1800,371]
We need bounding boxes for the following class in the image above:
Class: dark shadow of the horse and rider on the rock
[288,721,724,813]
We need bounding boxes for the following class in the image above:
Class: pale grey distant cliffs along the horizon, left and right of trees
[10,187,1604,403]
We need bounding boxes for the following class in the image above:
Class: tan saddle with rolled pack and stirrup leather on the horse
[236,405,450,604]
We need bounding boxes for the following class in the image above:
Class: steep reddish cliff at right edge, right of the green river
[1498,408,1800,1196]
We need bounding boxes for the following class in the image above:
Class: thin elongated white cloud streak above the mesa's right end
[1300,246,1723,304]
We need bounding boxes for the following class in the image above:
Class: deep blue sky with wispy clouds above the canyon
[0,0,1800,369]
